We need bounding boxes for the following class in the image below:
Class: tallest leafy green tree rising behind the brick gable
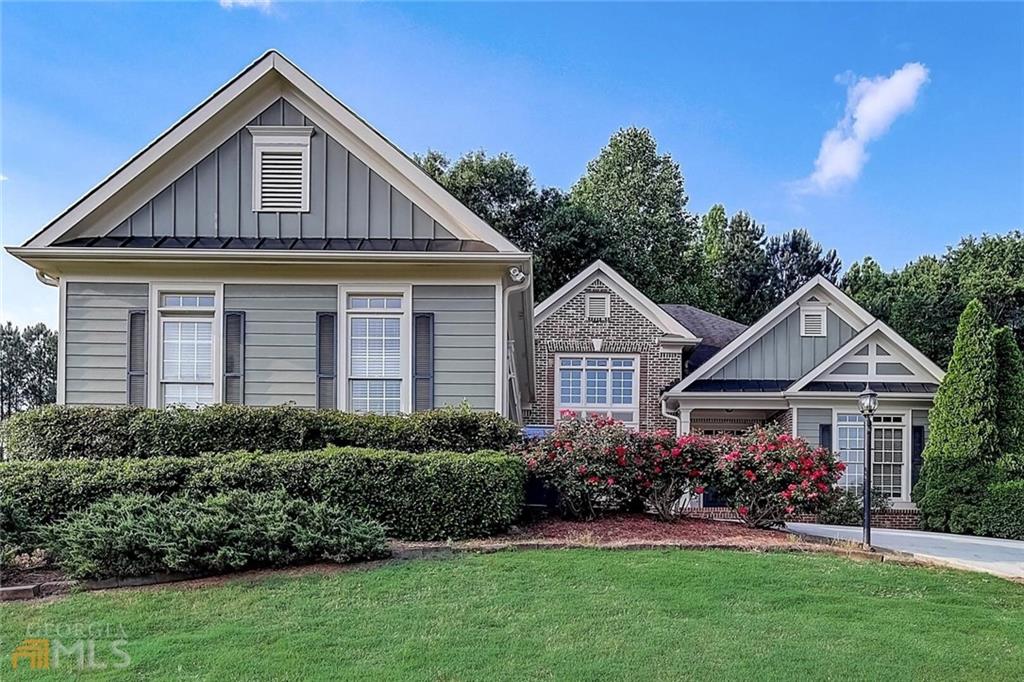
[569,128,702,302]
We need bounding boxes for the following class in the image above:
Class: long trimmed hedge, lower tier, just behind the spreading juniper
[0,446,525,548]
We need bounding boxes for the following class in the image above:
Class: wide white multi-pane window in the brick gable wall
[555,354,640,426]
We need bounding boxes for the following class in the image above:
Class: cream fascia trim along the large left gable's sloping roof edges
[24,50,522,254]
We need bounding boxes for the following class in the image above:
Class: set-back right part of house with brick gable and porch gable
[526,262,943,508]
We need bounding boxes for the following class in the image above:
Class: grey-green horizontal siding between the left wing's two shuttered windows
[224,284,338,408]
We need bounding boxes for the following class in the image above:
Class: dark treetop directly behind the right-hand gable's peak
[765,228,843,305]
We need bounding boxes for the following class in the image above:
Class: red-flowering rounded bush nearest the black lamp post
[715,429,845,528]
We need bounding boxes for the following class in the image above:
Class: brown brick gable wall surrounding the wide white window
[523,279,682,431]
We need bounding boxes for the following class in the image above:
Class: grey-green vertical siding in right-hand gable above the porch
[711,310,857,380]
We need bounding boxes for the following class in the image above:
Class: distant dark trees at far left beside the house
[0,322,57,419]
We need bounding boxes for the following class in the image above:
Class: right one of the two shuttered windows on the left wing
[343,293,410,415]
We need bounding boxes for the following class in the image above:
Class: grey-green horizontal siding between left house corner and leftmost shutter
[62,282,150,406]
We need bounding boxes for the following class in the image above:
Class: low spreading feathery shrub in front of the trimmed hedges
[43,491,387,579]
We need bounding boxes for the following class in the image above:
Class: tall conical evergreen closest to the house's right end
[913,299,998,530]
